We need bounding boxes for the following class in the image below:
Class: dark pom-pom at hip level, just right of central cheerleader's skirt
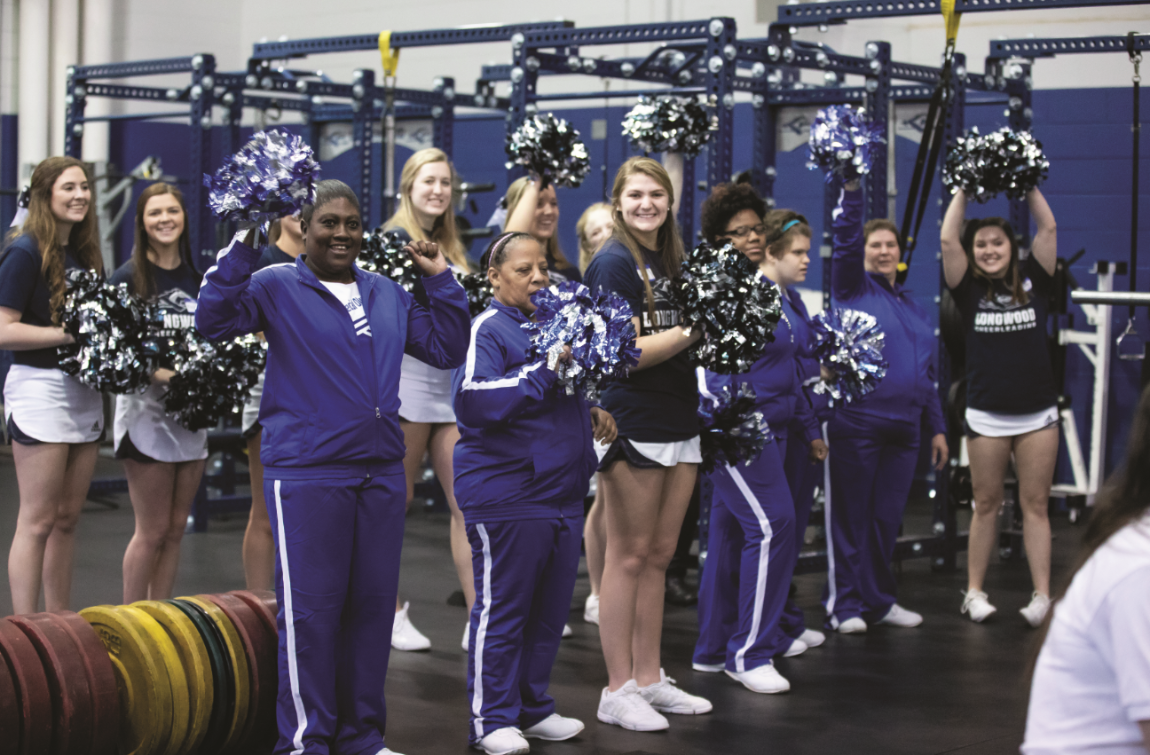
[699,383,774,472]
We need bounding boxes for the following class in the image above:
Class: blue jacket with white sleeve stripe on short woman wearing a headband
[453,300,597,522]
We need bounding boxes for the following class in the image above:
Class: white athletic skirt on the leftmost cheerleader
[3,364,104,444]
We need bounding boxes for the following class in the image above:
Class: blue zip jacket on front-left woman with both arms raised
[196,240,470,479]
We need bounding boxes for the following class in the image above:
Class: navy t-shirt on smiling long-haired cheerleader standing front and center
[583,239,699,444]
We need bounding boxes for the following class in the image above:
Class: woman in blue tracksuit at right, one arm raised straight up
[823,182,948,634]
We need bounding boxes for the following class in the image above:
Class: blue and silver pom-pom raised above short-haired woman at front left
[204,131,320,225]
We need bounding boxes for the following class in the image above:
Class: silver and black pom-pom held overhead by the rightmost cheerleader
[942,126,1050,202]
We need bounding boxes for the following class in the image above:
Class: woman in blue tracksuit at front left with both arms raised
[196,180,470,755]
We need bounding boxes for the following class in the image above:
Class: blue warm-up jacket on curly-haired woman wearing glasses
[699,277,822,442]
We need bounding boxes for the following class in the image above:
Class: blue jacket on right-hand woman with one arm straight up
[830,190,946,436]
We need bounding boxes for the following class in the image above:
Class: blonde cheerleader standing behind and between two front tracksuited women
[384,147,475,650]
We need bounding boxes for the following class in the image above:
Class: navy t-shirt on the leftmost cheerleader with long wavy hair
[0,236,81,370]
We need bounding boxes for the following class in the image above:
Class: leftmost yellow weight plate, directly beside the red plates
[79,606,173,755]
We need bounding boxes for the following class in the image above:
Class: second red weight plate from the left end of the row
[8,614,92,755]
